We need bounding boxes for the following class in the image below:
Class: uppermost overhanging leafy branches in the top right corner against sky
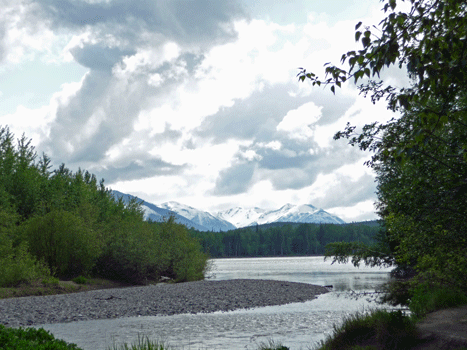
[299,0,467,116]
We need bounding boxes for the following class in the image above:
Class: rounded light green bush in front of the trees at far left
[24,210,101,277]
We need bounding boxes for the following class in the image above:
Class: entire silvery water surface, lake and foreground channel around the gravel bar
[33,257,390,350]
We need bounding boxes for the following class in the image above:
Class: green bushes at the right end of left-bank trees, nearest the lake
[96,219,208,284]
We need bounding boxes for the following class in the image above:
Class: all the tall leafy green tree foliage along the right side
[299,0,467,300]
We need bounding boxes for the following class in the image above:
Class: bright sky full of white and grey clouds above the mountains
[0,0,407,222]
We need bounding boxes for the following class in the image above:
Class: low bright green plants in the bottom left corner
[0,325,80,350]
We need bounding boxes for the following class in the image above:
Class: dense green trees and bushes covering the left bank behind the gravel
[0,127,207,286]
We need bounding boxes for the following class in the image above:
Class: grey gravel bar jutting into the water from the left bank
[0,279,328,327]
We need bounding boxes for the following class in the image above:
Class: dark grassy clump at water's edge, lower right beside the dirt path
[319,310,417,350]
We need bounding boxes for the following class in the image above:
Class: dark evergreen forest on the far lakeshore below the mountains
[191,223,380,258]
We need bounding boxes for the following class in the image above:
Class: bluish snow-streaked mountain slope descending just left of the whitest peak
[159,201,236,232]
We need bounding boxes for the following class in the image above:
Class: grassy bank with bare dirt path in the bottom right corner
[317,305,467,350]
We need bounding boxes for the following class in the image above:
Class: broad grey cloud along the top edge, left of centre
[36,0,243,46]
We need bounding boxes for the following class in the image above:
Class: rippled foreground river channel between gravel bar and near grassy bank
[37,292,394,350]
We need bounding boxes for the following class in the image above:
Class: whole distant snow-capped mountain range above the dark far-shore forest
[112,191,345,232]
